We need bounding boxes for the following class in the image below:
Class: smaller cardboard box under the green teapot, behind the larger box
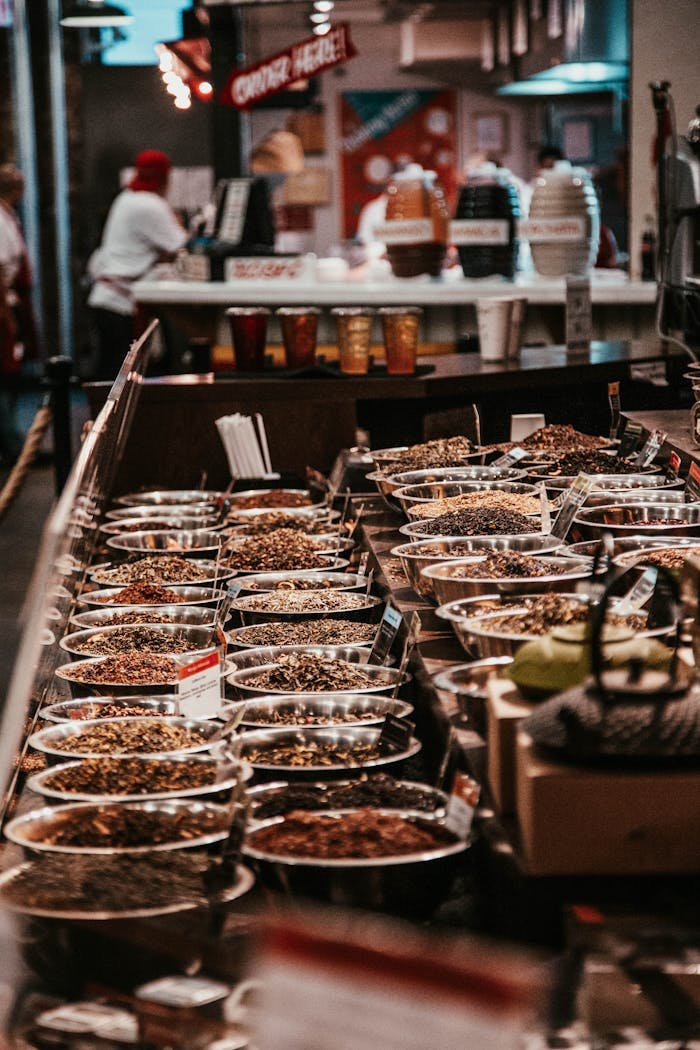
[486,678,532,816]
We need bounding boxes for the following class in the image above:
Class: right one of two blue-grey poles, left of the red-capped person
[47,0,72,357]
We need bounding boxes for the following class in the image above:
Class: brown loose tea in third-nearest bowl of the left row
[44,758,216,795]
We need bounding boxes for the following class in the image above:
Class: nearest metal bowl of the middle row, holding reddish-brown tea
[243,810,468,919]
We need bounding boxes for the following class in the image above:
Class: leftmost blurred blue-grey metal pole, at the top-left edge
[9,0,44,340]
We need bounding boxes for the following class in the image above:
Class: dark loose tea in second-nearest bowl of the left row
[25,804,226,848]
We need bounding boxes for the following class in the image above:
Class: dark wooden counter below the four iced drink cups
[86,341,684,491]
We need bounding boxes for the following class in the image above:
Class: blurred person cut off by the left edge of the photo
[0,164,38,463]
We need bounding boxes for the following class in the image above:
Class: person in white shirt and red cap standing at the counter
[87,149,188,379]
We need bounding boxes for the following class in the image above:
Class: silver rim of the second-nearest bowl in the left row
[3,799,230,856]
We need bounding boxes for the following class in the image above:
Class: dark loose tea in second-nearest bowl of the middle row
[253,773,443,820]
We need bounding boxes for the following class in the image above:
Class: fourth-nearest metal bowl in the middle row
[235,693,413,730]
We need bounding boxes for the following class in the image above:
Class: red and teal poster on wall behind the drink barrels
[340,88,458,238]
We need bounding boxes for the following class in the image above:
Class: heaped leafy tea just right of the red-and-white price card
[246,653,390,693]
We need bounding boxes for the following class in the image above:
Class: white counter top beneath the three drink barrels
[133,270,656,307]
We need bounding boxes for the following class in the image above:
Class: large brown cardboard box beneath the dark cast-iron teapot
[515,730,700,875]
